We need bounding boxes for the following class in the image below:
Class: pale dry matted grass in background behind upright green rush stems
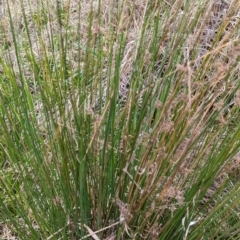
[1,0,240,96]
